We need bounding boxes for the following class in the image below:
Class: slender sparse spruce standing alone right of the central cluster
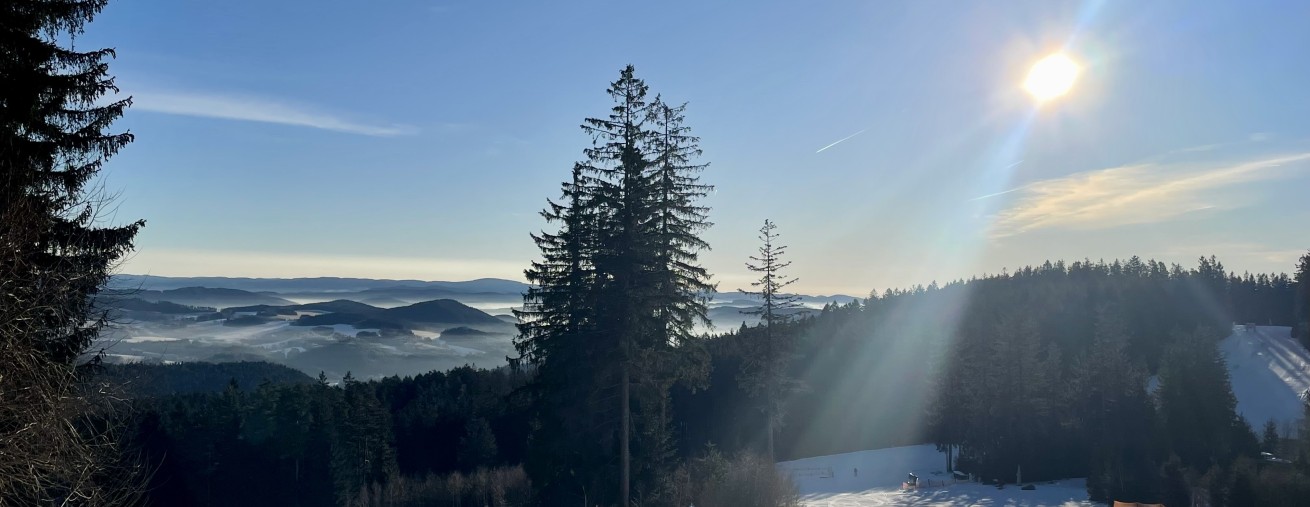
[738,219,800,460]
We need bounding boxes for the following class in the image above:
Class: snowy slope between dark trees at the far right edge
[1220,326,1310,431]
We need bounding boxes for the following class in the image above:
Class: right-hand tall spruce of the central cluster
[631,96,715,494]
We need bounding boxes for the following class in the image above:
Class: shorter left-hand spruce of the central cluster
[511,164,613,503]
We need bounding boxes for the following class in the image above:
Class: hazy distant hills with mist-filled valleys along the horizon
[99,275,854,379]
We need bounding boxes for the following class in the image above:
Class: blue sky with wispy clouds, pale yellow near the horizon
[84,0,1310,296]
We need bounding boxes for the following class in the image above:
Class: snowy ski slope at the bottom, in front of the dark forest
[778,445,1099,507]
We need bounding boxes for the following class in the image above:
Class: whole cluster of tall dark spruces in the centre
[516,66,714,504]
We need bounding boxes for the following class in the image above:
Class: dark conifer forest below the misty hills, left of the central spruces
[118,363,528,506]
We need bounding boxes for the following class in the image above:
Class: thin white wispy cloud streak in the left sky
[132,92,417,138]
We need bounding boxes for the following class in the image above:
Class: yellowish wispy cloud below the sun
[993,153,1310,237]
